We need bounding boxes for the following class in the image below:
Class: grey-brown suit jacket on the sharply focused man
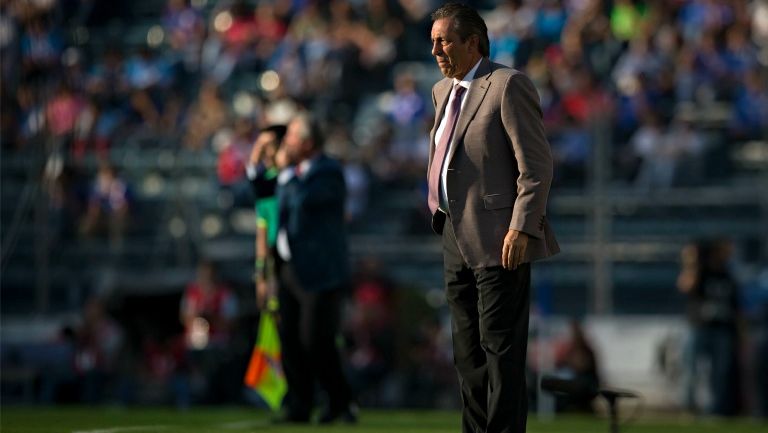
[427,58,560,268]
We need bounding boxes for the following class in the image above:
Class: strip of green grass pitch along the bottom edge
[0,407,768,433]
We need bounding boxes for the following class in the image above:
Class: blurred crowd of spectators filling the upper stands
[0,0,768,197]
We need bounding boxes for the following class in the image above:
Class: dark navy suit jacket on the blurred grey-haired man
[277,155,349,291]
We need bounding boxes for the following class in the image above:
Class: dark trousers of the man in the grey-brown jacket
[443,219,531,433]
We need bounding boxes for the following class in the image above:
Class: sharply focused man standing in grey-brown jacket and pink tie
[428,3,559,433]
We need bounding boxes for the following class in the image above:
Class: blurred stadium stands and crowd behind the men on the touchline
[0,0,768,418]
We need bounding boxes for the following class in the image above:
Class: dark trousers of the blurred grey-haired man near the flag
[278,263,350,418]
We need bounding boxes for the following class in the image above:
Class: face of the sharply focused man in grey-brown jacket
[431,18,479,79]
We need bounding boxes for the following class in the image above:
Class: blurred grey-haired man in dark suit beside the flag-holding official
[257,114,356,423]
